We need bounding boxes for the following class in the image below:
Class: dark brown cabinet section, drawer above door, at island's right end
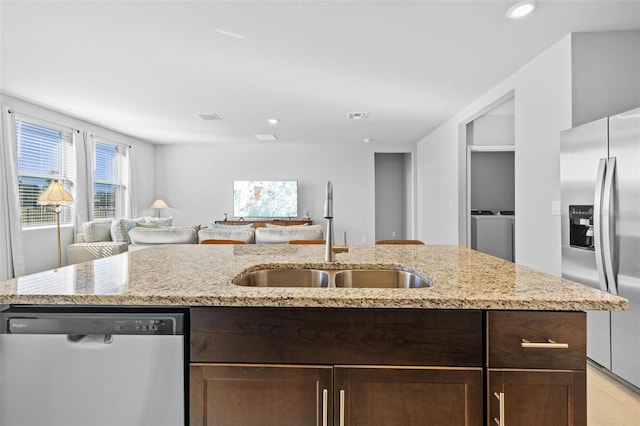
[487,311,587,426]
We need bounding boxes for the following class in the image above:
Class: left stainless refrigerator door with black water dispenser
[560,118,611,368]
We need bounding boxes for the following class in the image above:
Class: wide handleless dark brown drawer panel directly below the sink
[191,307,483,367]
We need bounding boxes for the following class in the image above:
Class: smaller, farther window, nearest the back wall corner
[93,140,129,219]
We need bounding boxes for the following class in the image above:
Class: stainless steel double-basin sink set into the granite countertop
[233,268,433,288]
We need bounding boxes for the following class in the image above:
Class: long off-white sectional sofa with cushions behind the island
[67,216,323,265]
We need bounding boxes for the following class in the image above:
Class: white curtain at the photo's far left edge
[0,106,25,280]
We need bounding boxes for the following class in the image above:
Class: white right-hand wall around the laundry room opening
[417,36,571,274]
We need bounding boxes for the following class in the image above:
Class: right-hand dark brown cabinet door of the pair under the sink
[334,367,483,426]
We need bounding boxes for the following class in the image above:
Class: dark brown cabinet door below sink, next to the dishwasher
[189,364,333,426]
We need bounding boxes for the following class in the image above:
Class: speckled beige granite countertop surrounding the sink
[0,244,627,311]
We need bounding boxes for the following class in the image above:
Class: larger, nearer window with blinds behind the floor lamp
[16,116,75,228]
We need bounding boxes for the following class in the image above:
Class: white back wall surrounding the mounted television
[155,143,415,244]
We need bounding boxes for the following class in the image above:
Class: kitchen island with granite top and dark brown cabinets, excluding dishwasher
[0,245,627,425]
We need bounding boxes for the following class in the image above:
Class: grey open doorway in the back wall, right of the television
[374,152,411,241]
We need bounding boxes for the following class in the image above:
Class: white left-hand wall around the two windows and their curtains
[0,95,155,274]
